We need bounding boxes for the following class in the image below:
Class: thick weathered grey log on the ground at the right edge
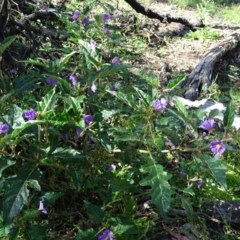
[182,31,240,100]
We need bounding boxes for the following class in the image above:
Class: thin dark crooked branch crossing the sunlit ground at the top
[125,0,204,30]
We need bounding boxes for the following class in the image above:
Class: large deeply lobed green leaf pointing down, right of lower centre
[140,158,172,215]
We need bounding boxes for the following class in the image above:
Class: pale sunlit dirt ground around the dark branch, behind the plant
[120,1,240,85]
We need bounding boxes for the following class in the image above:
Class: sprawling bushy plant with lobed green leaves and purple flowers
[0,1,239,239]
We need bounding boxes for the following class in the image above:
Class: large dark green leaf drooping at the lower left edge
[3,164,39,224]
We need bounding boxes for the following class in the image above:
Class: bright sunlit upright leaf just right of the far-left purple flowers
[38,88,57,115]
